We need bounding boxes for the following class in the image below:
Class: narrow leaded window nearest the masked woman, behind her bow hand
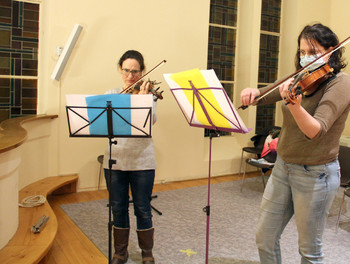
[256,0,282,132]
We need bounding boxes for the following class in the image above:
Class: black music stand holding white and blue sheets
[66,94,153,263]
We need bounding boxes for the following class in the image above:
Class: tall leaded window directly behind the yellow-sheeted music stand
[204,0,237,136]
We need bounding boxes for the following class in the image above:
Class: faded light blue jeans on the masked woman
[256,156,340,264]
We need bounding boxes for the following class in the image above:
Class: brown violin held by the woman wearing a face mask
[284,63,333,104]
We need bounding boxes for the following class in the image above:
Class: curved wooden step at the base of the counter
[0,175,78,264]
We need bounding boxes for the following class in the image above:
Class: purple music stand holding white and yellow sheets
[164,69,251,264]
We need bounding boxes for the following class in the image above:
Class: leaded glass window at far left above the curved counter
[0,0,40,122]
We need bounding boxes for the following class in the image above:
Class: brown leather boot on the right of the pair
[136,228,155,264]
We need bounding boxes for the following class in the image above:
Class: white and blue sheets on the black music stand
[66,94,153,136]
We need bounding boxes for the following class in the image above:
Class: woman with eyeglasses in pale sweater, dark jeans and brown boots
[103,50,157,264]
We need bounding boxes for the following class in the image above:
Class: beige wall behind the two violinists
[33,0,350,190]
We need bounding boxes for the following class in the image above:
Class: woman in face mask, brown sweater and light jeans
[241,24,350,264]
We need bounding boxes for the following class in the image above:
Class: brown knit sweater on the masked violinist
[259,72,350,165]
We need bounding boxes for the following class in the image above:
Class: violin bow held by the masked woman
[238,36,350,110]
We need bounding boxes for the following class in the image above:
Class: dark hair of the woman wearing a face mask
[295,23,347,73]
